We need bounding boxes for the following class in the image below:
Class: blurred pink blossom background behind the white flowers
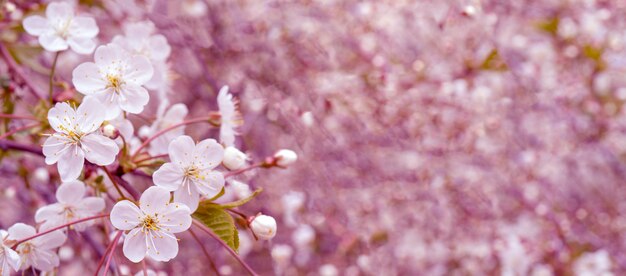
[0,0,626,276]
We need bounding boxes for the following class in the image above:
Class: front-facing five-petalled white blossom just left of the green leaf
[111,186,191,263]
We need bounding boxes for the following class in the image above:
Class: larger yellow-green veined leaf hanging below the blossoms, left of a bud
[193,203,239,252]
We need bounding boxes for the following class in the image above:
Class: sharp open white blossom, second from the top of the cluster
[72,43,153,120]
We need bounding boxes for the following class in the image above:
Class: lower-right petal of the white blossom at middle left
[80,133,120,166]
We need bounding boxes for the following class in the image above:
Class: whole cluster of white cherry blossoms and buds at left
[0,2,297,276]
